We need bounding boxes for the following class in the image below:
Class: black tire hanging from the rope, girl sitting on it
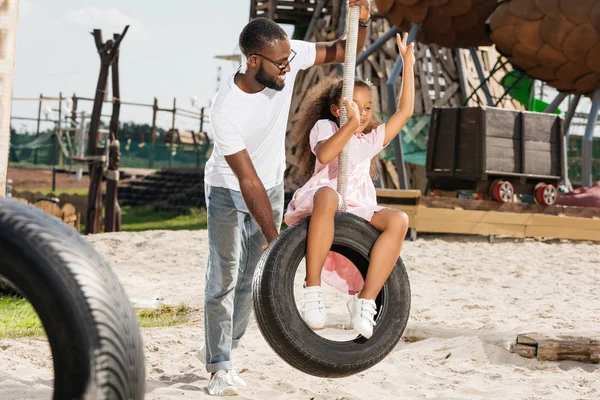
[252,213,410,378]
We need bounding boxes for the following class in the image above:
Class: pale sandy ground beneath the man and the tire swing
[0,231,600,399]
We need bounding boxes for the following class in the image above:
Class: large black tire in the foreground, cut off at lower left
[0,199,145,400]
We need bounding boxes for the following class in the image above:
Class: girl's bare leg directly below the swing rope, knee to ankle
[306,187,339,287]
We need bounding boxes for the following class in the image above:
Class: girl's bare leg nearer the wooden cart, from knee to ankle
[358,208,408,300]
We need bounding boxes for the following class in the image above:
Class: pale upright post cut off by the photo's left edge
[0,0,19,197]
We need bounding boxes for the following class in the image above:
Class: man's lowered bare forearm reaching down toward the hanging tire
[225,149,279,243]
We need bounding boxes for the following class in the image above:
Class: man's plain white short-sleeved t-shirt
[204,40,316,190]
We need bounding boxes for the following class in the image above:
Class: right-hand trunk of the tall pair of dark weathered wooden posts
[104,34,121,232]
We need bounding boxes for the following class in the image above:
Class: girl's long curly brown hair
[292,78,380,181]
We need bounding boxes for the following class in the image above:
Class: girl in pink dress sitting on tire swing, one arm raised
[285,34,415,339]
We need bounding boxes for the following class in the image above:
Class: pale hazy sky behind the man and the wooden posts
[12,0,293,132]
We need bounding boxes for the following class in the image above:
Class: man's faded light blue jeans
[204,183,284,372]
